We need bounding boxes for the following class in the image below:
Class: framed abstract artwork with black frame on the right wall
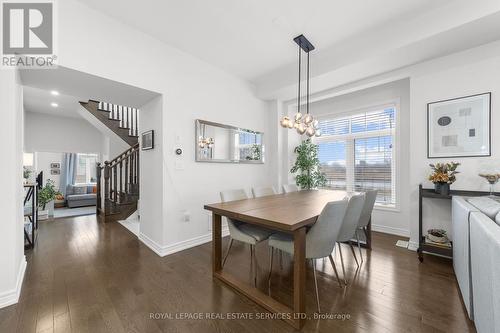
[427,92,491,158]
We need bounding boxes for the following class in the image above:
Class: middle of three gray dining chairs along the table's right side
[337,193,365,284]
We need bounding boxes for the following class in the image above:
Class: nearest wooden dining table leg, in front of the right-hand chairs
[293,227,306,329]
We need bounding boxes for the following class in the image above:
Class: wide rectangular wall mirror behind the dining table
[195,119,264,163]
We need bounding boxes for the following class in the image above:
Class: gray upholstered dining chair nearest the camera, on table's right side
[268,198,348,312]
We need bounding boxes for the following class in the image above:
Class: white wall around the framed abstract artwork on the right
[409,52,500,242]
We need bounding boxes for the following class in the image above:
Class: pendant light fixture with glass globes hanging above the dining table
[280,35,321,137]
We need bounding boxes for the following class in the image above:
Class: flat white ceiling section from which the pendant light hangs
[77,0,454,82]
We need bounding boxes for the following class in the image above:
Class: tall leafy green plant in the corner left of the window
[290,139,326,190]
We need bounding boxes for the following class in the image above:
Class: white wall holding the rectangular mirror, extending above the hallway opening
[53,0,274,253]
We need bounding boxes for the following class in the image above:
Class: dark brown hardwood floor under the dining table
[0,216,475,333]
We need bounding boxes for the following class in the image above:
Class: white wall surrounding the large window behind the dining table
[288,79,410,236]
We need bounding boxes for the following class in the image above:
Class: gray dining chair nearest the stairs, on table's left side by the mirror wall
[220,190,272,285]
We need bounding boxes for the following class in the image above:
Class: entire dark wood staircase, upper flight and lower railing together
[80,100,139,222]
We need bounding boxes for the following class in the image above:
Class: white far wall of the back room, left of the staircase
[24,112,103,153]
